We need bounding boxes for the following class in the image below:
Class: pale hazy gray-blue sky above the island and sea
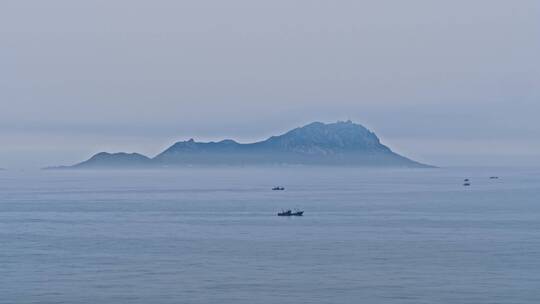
[0,0,540,168]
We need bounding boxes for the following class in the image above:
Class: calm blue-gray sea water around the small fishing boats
[0,168,540,304]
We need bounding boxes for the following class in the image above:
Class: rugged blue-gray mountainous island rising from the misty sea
[46,121,432,169]
